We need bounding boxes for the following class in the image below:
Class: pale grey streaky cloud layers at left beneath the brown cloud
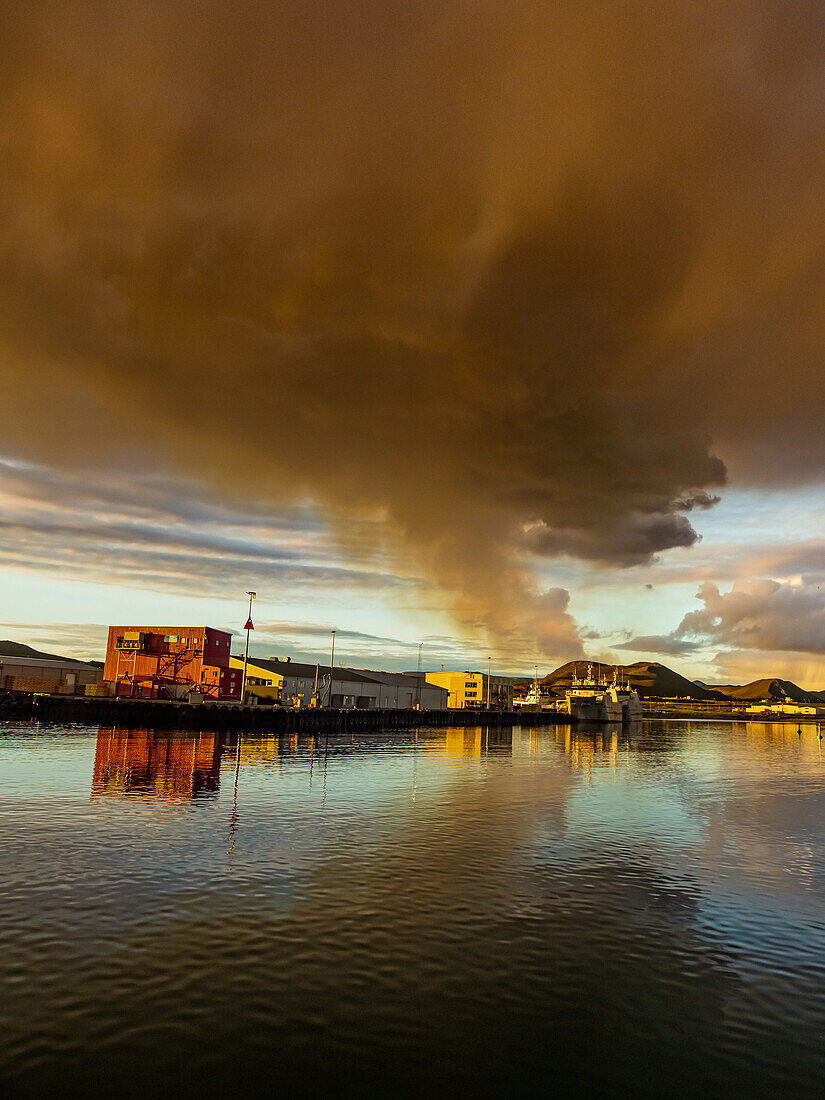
[0,459,402,601]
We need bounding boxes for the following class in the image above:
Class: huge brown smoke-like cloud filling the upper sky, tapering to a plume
[0,0,825,656]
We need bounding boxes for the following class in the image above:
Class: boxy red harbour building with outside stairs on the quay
[103,626,242,701]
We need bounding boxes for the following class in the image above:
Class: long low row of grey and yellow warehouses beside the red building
[230,657,447,711]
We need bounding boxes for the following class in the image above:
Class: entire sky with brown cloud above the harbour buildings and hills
[0,0,825,688]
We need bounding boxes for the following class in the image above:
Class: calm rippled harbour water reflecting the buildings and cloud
[0,722,825,1097]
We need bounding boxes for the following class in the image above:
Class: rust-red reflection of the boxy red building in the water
[91,727,227,800]
